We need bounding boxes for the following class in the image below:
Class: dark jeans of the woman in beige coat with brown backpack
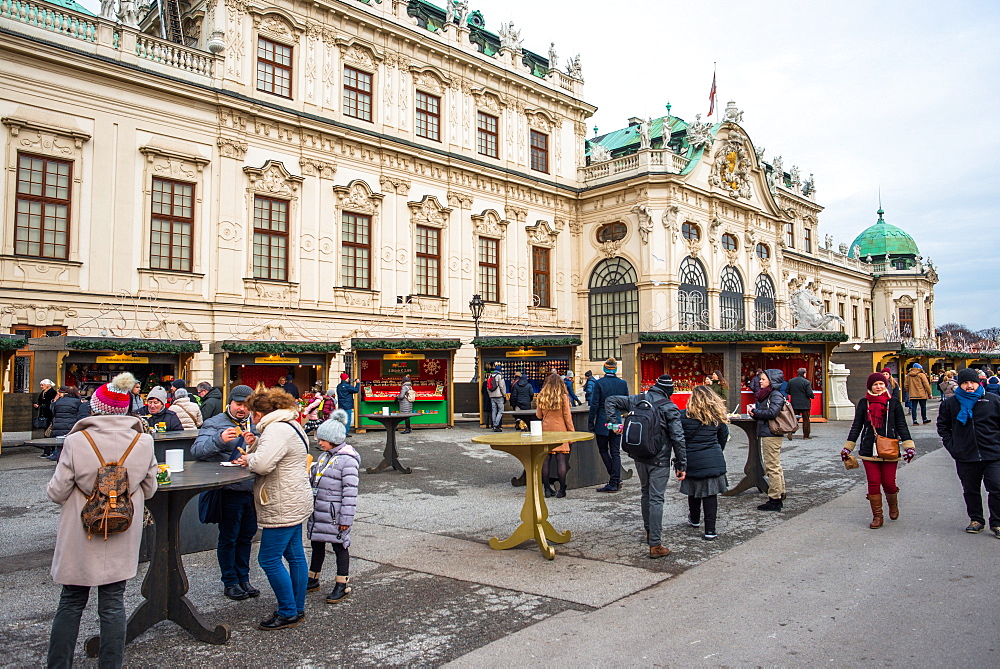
[48,581,126,669]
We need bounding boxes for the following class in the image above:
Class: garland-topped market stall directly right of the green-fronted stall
[472,335,583,426]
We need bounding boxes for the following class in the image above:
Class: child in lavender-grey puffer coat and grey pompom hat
[306,409,361,604]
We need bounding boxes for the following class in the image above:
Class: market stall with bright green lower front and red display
[351,338,462,430]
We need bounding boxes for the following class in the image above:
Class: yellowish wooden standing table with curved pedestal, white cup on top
[472,432,594,560]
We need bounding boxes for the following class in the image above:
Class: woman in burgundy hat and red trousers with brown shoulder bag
[840,372,914,530]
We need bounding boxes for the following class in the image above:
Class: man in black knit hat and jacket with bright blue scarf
[937,362,1000,539]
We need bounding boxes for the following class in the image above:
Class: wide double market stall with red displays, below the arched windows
[619,331,846,416]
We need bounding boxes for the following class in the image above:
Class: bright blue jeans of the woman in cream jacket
[257,523,309,618]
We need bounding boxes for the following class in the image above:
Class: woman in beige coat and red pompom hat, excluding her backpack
[46,373,157,667]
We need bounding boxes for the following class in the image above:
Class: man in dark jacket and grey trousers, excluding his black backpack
[598,374,687,559]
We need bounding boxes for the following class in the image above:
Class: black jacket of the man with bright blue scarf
[937,393,1000,462]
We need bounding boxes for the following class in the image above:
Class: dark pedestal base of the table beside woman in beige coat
[84,490,230,657]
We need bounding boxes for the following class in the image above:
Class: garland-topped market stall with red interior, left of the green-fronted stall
[208,340,340,397]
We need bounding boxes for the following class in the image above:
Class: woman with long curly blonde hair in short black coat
[681,386,729,541]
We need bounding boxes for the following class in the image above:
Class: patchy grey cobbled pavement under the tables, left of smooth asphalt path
[0,404,939,667]
